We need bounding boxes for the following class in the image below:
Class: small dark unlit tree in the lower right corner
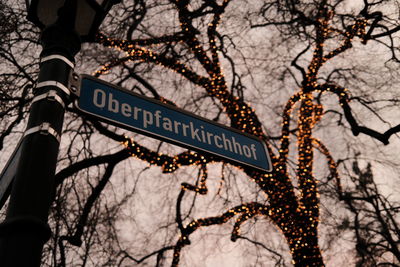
[340,161,400,266]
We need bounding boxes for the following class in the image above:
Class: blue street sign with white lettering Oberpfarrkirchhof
[76,75,272,171]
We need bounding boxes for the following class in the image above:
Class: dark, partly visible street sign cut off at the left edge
[0,138,22,210]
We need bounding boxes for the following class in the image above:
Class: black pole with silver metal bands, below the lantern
[0,25,80,267]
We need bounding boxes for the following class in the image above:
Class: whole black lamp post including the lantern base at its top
[0,0,119,267]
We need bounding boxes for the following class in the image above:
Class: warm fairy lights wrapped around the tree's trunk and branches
[90,0,367,266]
